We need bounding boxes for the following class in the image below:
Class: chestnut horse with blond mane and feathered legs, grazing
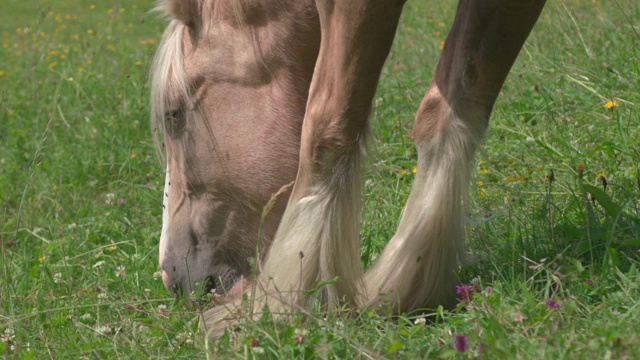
[151,0,545,331]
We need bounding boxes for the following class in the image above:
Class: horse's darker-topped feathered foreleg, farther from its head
[365,0,545,313]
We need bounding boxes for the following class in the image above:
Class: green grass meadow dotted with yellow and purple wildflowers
[0,0,640,359]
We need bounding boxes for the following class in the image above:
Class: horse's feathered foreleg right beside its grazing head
[254,0,404,309]
